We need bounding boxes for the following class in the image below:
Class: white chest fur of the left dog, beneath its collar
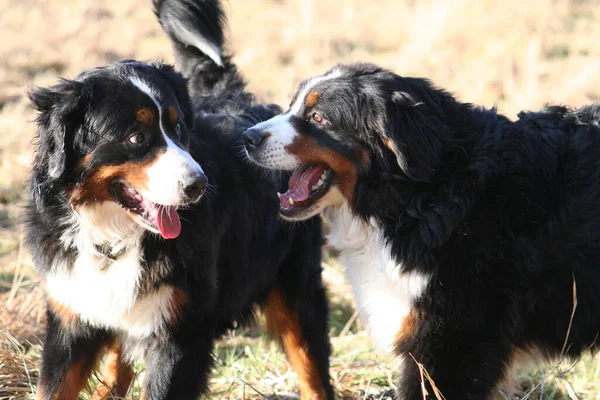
[46,203,174,337]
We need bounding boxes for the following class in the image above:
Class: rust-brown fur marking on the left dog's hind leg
[263,289,327,400]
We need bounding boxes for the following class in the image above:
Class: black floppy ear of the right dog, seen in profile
[380,91,449,182]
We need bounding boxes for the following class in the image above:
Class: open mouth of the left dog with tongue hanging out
[111,180,181,239]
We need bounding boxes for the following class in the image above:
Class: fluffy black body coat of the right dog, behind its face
[354,67,600,399]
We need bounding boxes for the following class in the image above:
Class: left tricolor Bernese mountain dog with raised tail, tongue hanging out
[26,0,333,400]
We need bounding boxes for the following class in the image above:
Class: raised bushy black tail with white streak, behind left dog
[153,0,254,111]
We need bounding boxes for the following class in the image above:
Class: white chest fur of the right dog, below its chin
[323,204,429,351]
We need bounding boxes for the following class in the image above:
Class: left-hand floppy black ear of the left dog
[28,80,82,179]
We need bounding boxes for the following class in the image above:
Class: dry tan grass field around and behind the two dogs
[0,0,600,400]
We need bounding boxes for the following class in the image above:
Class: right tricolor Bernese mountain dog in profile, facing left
[244,64,600,400]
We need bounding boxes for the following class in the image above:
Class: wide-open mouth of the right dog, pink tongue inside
[277,164,333,216]
